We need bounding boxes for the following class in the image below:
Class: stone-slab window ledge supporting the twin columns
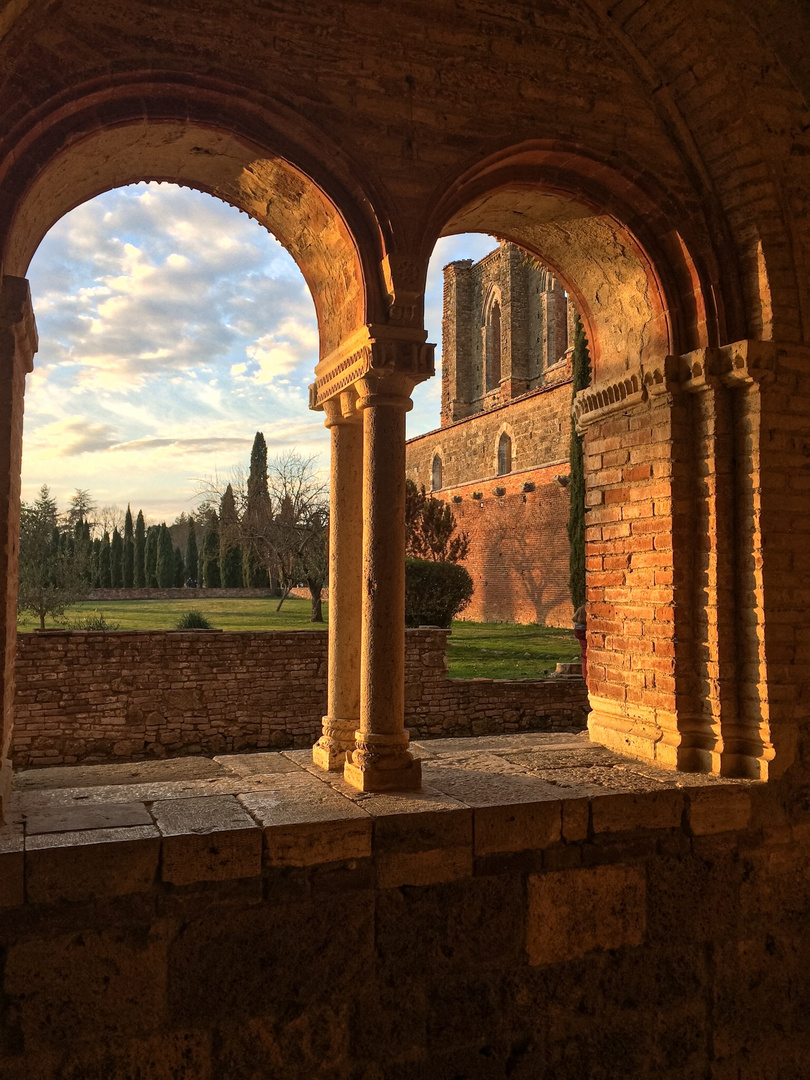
[0,732,761,909]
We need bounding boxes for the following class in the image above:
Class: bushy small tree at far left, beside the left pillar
[17,484,89,630]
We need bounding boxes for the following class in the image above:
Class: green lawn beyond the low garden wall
[17,598,579,678]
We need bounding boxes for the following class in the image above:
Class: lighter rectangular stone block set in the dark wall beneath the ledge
[526,866,647,966]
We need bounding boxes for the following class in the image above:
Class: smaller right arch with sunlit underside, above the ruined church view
[428,143,741,380]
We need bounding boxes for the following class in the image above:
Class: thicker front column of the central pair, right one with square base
[343,372,421,792]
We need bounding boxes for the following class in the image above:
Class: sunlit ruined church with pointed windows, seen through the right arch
[406,243,576,626]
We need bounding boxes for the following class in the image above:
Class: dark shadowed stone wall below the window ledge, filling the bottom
[0,769,810,1080]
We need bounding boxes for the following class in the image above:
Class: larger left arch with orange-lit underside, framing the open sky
[0,78,390,359]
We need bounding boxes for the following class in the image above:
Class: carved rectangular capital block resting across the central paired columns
[310,323,435,410]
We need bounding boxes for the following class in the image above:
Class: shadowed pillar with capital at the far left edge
[0,276,37,823]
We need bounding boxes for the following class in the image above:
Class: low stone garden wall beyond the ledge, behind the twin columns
[13,630,588,767]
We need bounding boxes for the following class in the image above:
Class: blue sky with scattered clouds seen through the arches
[23,184,495,522]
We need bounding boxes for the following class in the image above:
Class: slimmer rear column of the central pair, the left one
[312,391,363,769]
